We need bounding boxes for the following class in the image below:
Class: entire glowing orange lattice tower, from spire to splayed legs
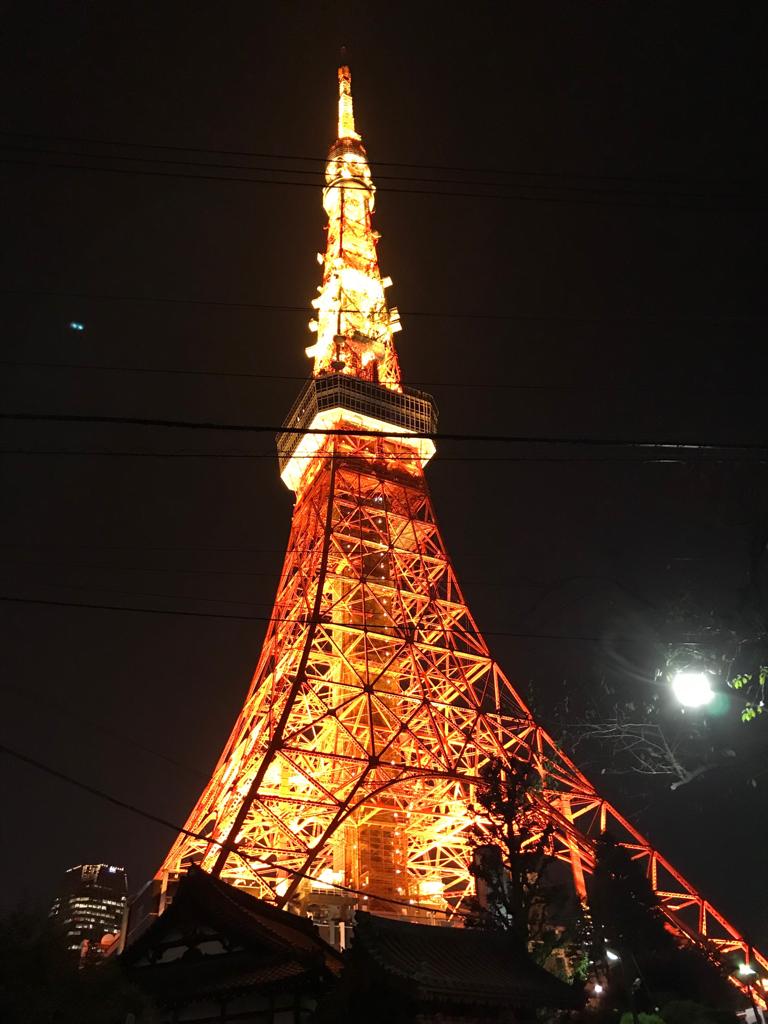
[158,68,768,983]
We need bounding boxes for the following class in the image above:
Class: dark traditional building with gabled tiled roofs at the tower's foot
[121,867,584,1024]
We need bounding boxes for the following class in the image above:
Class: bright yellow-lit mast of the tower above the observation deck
[306,65,402,392]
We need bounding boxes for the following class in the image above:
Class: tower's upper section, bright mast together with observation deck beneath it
[278,63,437,492]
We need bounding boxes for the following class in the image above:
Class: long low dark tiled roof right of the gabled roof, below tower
[354,911,584,1008]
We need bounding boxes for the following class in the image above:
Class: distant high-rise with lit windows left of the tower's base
[49,864,128,964]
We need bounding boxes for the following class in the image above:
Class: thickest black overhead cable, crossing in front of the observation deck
[0,413,768,458]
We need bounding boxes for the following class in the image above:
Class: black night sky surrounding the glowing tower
[0,0,768,941]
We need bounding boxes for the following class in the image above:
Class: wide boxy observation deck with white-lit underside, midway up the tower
[276,374,437,490]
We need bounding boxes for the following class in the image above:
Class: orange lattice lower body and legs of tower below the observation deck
[159,428,768,987]
